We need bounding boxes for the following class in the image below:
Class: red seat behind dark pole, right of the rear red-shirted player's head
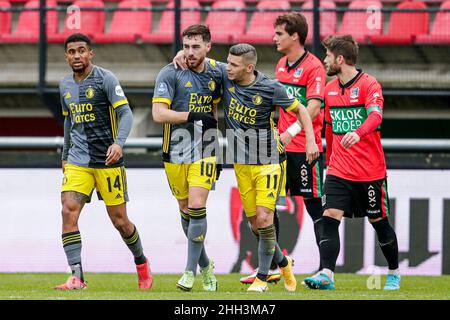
[302,0,336,43]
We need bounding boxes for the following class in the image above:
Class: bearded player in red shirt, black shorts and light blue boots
[305,35,400,290]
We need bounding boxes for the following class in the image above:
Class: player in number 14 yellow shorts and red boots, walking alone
[55,33,153,290]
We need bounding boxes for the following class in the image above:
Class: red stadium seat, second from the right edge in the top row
[370,1,429,45]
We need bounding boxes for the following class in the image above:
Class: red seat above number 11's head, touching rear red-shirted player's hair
[233,0,291,44]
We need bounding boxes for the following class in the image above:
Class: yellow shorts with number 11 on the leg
[234,162,286,217]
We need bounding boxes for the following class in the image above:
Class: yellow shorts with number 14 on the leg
[61,164,128,206]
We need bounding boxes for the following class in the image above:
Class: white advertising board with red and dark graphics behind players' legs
[0,168,450,275]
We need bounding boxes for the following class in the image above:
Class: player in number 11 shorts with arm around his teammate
[222,44,319,292]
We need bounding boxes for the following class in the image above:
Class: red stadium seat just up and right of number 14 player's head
[94,0,152,42]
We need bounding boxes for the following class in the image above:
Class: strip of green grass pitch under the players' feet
[0,273,450,300]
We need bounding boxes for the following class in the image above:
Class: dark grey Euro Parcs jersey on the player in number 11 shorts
[222,67,299,164]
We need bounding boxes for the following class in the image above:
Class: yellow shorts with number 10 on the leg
[164,157,217,200]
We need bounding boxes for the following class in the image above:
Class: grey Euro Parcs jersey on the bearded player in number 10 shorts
[153,60,223,163]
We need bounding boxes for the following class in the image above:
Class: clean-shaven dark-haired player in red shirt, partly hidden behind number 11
[241,12,326,283]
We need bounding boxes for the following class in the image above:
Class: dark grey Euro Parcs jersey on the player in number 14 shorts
[59,66,128,168]
